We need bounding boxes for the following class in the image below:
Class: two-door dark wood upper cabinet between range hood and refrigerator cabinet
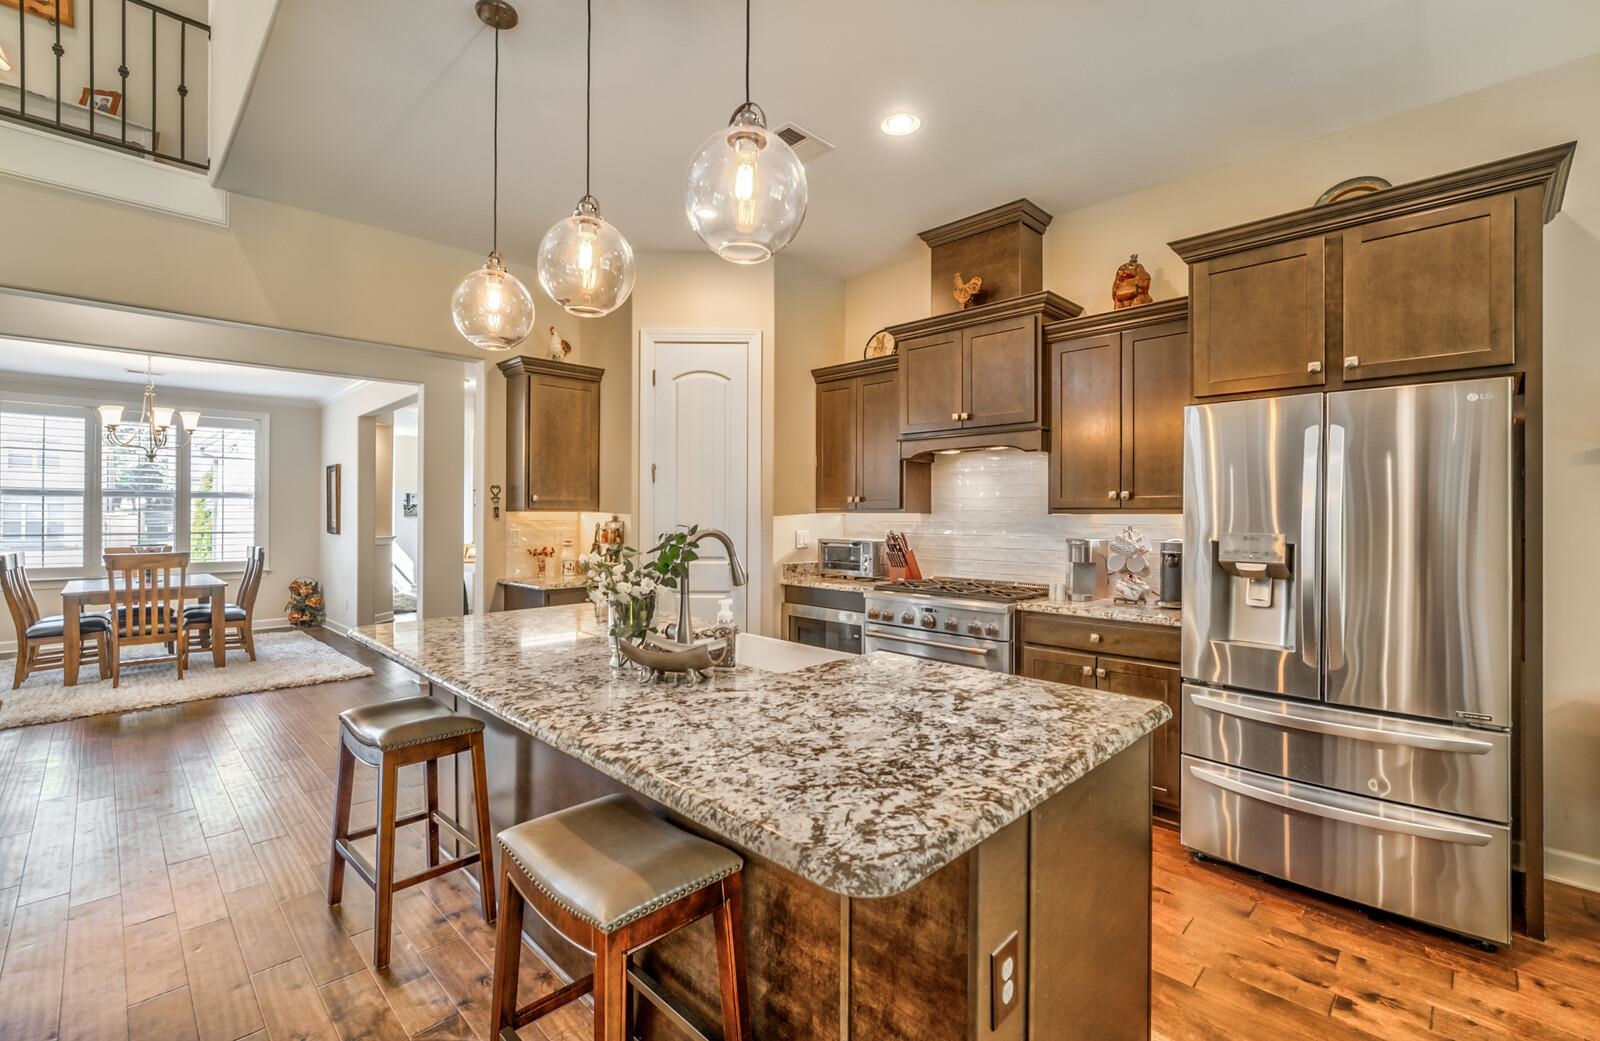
[1045,299,1189,513]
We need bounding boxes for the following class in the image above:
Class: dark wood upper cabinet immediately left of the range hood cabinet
[811,357,931,513]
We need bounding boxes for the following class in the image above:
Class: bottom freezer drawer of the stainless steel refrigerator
[1182,755,1510,943]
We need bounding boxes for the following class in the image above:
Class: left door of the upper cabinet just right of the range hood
[1050,333,1123,510]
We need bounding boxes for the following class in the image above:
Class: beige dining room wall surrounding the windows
[0,370,322,652]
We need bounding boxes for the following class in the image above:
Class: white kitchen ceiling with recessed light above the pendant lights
[218,0,1600,277]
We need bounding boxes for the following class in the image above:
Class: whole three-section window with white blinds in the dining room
[0,401,267,574]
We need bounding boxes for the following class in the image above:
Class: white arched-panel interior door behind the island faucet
[640,341,757,628]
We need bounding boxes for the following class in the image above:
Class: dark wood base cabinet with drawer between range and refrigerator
[1019,611,1182,820]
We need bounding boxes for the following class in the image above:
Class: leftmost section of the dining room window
[0,403,88,568]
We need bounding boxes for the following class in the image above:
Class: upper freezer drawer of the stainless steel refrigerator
[1182,684,1510,824]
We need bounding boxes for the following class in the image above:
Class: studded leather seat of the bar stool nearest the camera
[499,795,744,932]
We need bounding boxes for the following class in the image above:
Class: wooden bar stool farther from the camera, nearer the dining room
[328,697,494,967]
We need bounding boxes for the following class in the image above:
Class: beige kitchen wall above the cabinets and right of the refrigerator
[845,56,1600,887]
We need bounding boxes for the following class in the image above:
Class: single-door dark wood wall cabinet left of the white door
[499,357,605,510]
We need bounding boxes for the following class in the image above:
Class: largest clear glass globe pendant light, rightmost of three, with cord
[683,0,806,264]
